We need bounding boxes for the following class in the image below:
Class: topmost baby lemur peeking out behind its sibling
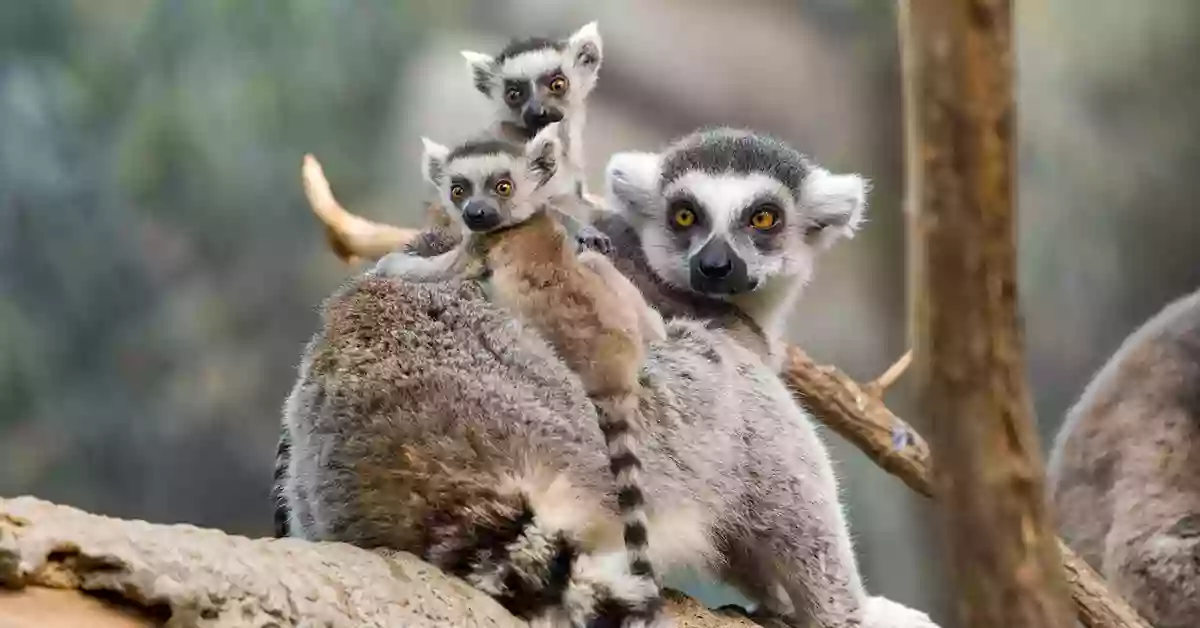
[462,22,610,253]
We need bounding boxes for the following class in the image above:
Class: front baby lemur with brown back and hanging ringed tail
[374,122,666,618]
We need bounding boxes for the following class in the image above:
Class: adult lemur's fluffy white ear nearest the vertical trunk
[803,168,870,249]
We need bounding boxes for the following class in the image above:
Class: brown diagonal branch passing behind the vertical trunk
[784,347,1151,628]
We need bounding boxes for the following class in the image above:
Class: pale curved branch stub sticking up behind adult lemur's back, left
[301,155,418,264]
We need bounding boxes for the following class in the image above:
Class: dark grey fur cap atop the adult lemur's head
[659,128,811,198]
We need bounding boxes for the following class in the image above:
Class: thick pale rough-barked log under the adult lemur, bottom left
[0,497,754,628]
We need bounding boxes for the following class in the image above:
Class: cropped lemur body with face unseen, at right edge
[1048,285,1200,628]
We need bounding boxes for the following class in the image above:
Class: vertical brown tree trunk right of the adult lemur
[900,0,1072,628]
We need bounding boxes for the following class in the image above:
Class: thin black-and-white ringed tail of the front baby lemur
[592,393,661,605]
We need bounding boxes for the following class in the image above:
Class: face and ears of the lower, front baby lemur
[421,124,562,233]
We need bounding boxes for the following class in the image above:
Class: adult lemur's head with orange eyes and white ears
[606,128,865,297]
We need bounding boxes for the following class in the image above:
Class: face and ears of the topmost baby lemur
[462,22,601,136]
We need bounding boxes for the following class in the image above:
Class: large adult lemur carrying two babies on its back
[284,121,932,627]
